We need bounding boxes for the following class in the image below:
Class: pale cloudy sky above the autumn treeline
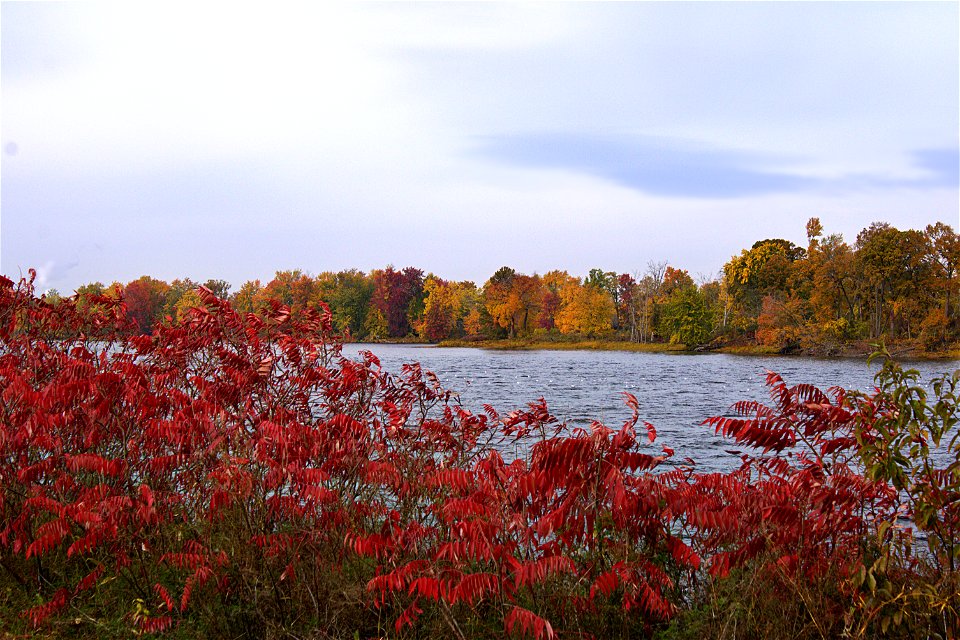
[0,0,960,293]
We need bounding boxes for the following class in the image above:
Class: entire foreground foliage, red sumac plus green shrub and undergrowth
[0,278,960,638]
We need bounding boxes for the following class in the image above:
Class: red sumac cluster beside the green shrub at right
[688,373,896,577]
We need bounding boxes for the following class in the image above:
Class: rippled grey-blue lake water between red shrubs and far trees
[343,344,960,471]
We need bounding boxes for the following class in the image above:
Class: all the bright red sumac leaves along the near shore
[0,272,936,638]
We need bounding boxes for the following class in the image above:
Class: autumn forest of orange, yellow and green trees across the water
[47,218,960,355]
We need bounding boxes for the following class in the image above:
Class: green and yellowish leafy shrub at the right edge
[847,350,960,638]
